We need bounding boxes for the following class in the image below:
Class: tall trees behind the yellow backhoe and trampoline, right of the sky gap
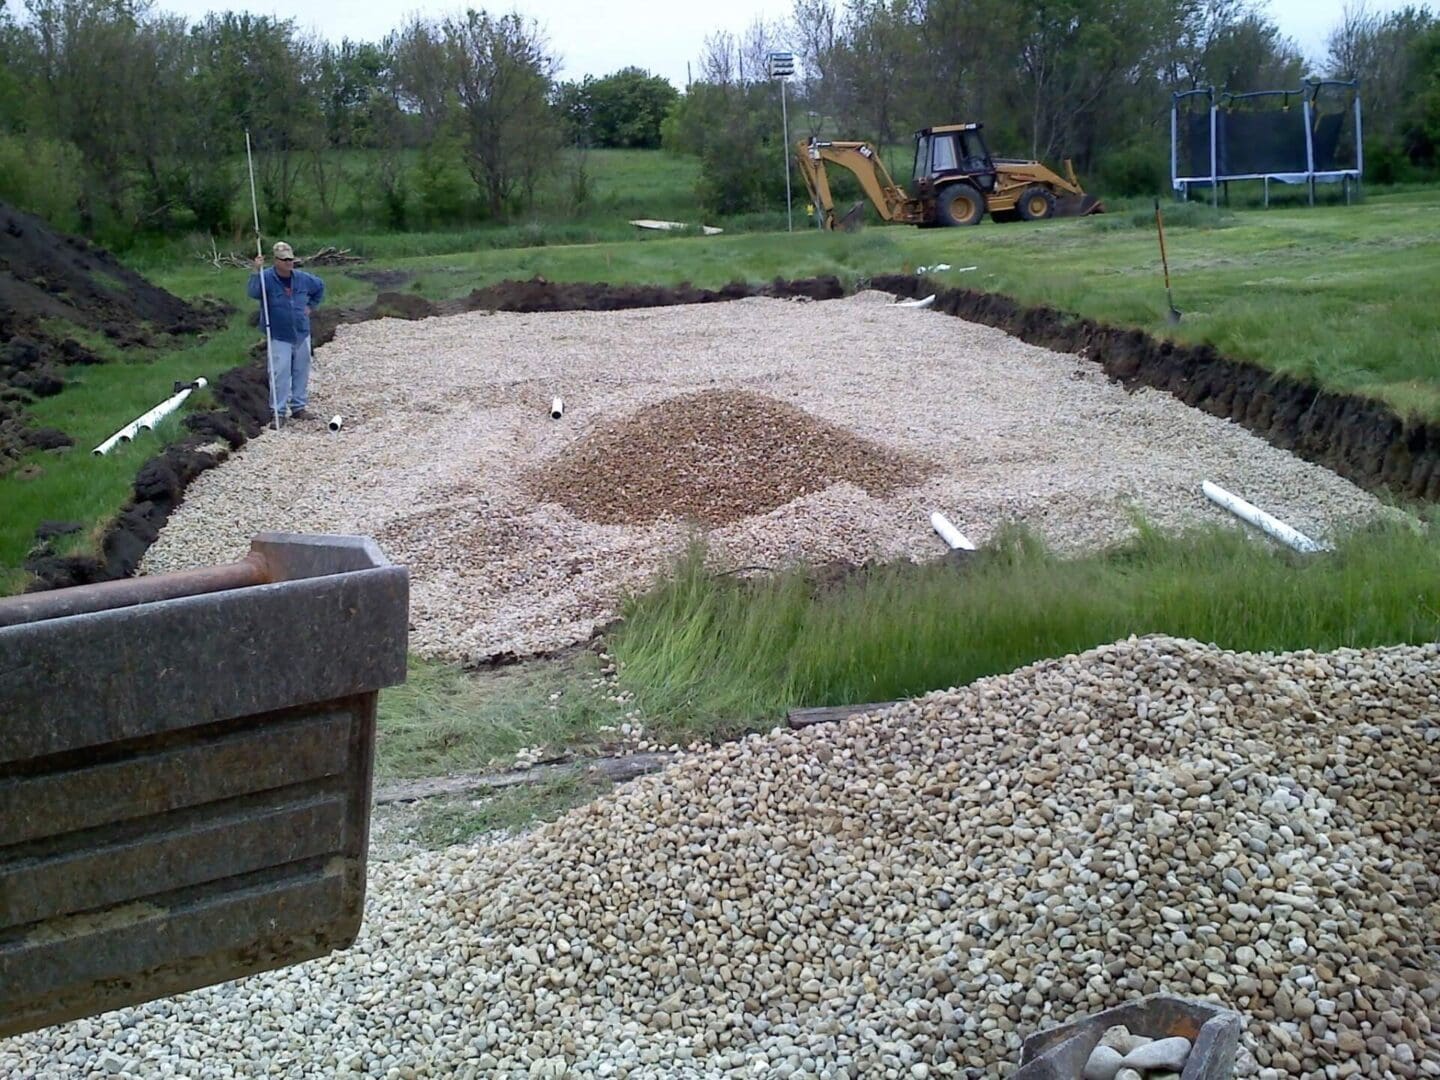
[667,0,1440,212]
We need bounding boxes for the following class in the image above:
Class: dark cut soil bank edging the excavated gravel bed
[16,274,1440,592]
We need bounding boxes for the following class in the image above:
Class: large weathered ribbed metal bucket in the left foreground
[0,533,409,1037]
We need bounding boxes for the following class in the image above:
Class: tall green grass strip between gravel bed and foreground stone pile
[609,517,1440,737]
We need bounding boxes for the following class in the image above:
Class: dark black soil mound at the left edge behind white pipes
[0,203,228,468]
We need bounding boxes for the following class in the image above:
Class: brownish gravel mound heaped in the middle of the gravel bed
[534,390,930,526]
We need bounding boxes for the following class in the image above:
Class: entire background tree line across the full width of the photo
[0,0,1440,243]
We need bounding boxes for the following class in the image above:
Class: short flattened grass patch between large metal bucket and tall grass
[376,652,625,778]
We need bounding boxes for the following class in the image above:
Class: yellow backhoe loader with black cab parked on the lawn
[795,124,1104,229]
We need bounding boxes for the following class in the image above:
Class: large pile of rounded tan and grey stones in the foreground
[0,638,1440,1080]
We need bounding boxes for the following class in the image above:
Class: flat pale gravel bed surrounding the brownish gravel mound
[143,292,1378,661]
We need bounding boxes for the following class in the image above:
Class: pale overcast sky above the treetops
[156,0,1404,88]
